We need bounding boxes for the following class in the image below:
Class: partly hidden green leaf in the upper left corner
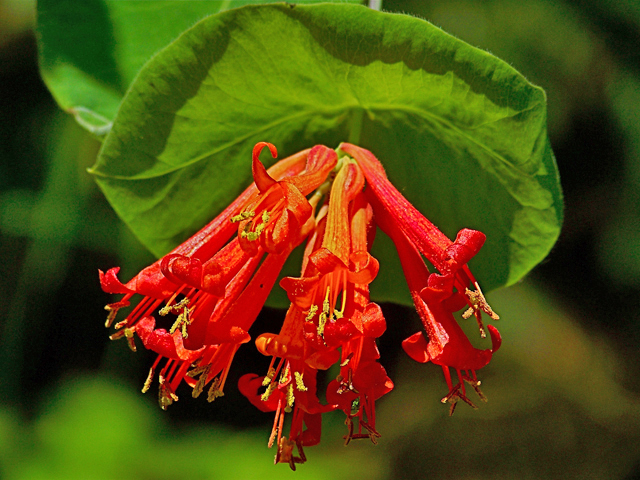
[38,0,362,137]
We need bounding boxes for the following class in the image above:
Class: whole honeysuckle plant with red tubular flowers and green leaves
[38,0,562,469]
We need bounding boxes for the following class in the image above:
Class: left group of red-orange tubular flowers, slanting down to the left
[100,143,336,408]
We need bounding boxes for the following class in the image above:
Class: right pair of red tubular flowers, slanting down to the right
[340,144,501,414]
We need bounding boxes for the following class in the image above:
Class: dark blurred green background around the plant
[0,0,640,480]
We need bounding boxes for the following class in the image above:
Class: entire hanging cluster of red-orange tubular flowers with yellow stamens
[100,142,500,470]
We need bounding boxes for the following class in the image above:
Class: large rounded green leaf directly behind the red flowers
[92,4,562,303]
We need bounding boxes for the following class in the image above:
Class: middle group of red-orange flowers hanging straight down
[243,160,393,468]
